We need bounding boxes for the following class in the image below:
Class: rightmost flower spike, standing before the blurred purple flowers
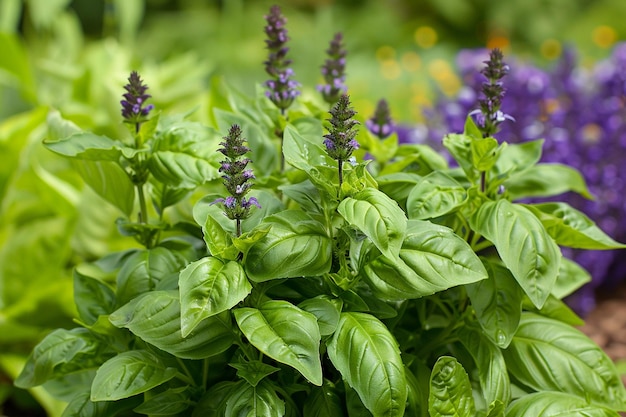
[470,48,514,137]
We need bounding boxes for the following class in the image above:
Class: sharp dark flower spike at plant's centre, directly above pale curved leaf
[324,94,359,187]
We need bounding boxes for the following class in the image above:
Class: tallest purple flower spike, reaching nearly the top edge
[264,5,300,112]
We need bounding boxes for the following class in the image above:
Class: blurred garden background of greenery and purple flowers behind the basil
[0,0,626,416]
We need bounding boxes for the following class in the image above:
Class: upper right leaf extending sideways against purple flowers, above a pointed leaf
[504,164,593,200]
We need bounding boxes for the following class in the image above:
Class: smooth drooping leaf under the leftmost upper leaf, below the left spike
[74,160,135,217]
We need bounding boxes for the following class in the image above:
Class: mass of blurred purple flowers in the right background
[410,44,626,314]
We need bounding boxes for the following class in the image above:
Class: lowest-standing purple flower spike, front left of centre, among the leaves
[213,125,261,236]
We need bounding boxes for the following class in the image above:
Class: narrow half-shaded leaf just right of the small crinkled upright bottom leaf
[457,325,511,404]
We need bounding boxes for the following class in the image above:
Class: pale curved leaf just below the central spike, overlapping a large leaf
[337,188,407,258]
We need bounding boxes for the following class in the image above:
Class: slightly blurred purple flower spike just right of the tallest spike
[317,32,348,104]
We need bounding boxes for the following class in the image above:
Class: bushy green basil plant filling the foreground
[16,16,626,417]
